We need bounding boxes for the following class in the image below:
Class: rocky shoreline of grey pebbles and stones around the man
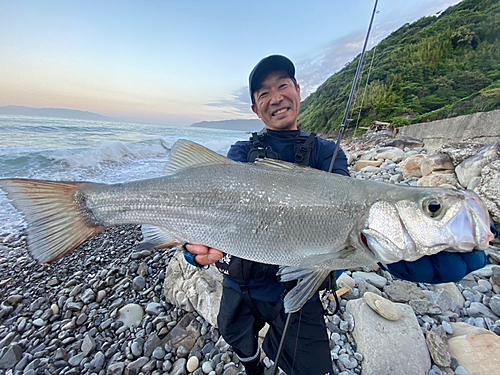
[0,136,500,375]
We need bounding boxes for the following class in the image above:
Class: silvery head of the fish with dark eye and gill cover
[361,188,494,263]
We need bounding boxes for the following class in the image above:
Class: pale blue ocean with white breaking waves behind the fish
[0,115,249,237]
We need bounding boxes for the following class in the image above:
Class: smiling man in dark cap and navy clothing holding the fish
[185,55,486,375]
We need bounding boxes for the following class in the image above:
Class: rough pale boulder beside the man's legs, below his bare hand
[164,250,222,327]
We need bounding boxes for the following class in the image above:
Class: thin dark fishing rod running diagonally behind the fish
[271,0,378,375]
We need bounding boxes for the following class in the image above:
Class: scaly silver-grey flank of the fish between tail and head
[85,164,379,267]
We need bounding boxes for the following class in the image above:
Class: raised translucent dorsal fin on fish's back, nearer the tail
[163,139,236,174]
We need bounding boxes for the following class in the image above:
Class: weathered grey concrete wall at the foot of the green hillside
[398,109,500,154]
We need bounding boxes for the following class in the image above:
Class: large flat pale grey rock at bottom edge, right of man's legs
[346,299,431,375]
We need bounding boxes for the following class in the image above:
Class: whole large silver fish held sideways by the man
[0,140,493,311]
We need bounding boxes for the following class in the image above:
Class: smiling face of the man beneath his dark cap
[252,70,300,130]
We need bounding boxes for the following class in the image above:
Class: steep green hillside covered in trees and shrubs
[299,0,500,133]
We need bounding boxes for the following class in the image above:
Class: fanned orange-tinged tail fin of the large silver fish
[0,179,106,263]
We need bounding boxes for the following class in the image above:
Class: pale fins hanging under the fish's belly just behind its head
[278,267,330,313]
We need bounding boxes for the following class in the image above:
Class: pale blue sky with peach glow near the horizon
[0,0,459,126]
